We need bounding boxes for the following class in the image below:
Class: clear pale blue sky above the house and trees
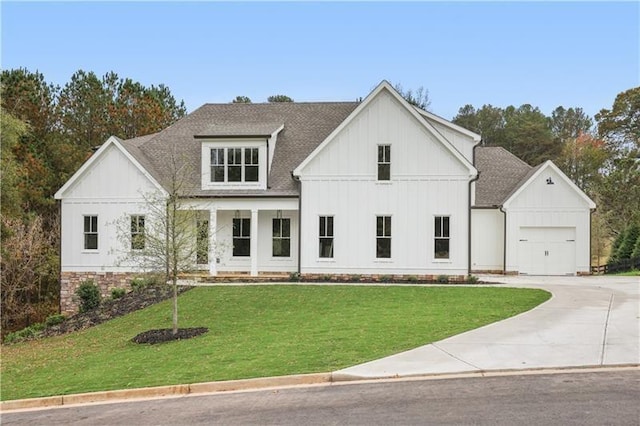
[0,1,640,119]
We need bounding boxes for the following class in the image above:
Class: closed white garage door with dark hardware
[518,227,576,275]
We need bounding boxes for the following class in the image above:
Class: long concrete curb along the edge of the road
[0,364,640,412]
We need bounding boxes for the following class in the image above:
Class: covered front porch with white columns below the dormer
[189,198,299,277]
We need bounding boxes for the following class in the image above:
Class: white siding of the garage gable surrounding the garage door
[505,167,591,273]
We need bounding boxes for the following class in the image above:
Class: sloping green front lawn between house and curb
[1,285,550,400]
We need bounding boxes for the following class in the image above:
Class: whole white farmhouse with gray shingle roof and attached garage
[55,81,595,310]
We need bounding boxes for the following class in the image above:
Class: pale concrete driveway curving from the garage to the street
[334,275,640,379]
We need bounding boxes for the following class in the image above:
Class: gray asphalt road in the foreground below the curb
[1,369,640,426]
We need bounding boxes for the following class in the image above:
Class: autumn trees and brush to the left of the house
[0,69,186,334]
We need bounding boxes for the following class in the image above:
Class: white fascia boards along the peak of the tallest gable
[293,80,478,177]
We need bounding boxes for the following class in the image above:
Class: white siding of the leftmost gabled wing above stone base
[57,144,157,272]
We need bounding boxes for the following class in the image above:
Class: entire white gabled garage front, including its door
[504,162,595,275]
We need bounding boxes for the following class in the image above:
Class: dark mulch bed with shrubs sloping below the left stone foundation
[42,285,192,337]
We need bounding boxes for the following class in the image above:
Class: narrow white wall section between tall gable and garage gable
[471,209,504,272]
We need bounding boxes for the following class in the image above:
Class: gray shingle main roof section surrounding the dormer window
[123,102,358,197]
